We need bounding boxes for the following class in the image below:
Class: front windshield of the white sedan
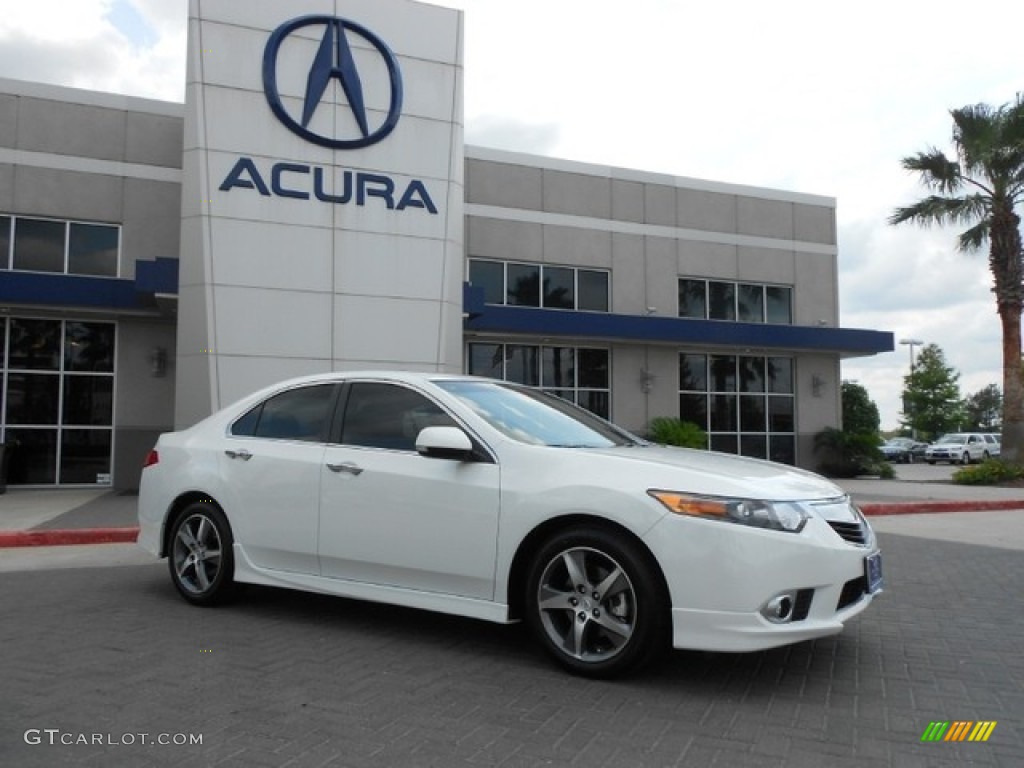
[434,380,640,447]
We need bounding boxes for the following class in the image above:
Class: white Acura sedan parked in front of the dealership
[138,373,882,677]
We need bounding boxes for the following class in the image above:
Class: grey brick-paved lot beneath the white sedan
[0,534,1024,768]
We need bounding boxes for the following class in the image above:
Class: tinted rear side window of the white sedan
[231,384,335,442]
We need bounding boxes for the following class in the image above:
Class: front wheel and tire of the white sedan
[525,526,670,678]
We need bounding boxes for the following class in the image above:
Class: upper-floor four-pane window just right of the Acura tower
[469,259,609,312]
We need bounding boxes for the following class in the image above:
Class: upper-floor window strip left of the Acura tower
[0,216,121,278]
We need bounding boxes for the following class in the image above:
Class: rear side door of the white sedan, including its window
[218,383,340,574]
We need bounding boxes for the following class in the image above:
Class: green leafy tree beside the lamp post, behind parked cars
[902,344,966,439]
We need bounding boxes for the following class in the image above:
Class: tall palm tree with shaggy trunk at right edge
[889,98,1024,464]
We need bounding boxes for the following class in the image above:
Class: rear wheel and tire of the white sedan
[167,502,236,605]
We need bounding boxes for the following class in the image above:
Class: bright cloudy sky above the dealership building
[0,0,1024,429]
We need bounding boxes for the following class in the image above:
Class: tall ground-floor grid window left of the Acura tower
[0,317,116,485]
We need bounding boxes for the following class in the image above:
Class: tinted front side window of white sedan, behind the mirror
[341,382,456,451]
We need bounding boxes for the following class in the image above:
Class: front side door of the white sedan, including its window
[319,382,500,600]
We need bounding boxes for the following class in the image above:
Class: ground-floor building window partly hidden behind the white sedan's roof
[466,342,611,419]
